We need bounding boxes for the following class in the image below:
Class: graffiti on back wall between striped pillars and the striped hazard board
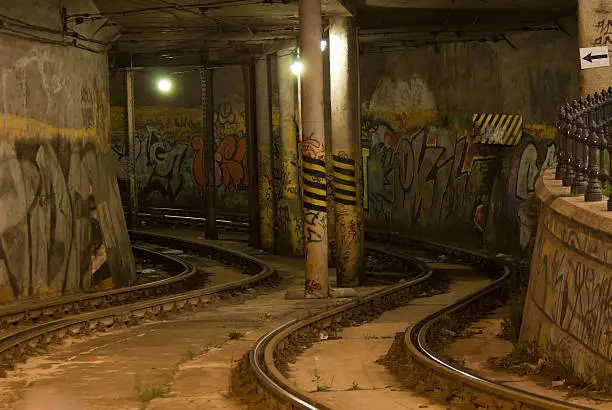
[362,111,495,243]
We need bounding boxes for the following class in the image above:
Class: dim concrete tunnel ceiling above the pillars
[85,0,576,66]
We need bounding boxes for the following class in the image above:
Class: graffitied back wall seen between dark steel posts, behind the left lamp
[111,66,280,212]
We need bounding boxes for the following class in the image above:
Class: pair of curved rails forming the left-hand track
[0,231,276,376]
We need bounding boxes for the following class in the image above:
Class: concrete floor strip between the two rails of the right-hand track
[291,271,490,410]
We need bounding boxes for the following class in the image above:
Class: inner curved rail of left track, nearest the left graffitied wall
[0,246,197,328]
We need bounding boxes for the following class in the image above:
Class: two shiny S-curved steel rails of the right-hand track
[238,235,588,410]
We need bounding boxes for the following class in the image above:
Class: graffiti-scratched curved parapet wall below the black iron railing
[521,206,612,381]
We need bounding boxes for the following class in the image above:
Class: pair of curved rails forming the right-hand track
[232,231,587,410]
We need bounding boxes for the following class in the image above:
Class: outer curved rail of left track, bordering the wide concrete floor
[0,231,276,373]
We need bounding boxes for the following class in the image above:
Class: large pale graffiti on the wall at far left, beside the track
[0,139,131,299]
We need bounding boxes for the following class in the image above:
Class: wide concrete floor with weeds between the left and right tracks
[0,231,372,410]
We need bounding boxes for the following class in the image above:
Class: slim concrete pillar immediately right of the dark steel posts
[255,57,276,252]
